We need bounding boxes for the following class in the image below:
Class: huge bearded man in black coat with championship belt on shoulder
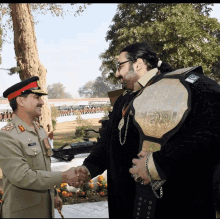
[75,43,220,218]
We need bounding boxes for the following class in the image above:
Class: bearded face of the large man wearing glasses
[116,52,139,90]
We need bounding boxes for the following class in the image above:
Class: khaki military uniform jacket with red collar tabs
[0,115,62,218]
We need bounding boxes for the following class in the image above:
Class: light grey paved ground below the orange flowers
[55,201,109,218]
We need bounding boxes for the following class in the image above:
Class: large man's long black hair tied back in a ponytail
[120,42,174,73]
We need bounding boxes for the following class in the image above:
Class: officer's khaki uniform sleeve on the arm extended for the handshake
[0,131,62,190]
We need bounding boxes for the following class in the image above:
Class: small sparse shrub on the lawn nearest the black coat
[75,110,92,139]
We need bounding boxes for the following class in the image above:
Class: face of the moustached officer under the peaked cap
[23,93,44,117]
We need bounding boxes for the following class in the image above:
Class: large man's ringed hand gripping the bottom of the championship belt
[129,151,150,185]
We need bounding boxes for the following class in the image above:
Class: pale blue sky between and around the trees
[0,3,220,98]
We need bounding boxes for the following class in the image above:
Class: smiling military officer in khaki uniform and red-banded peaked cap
[0,76,88,218]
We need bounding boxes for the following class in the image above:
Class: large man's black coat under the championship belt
[84,69,220,218]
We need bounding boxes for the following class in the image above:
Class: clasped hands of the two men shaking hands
[62,166,91,188]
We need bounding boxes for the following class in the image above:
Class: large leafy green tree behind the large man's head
[100,3,220,82]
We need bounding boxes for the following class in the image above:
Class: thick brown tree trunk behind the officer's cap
[9,3,53,136]
